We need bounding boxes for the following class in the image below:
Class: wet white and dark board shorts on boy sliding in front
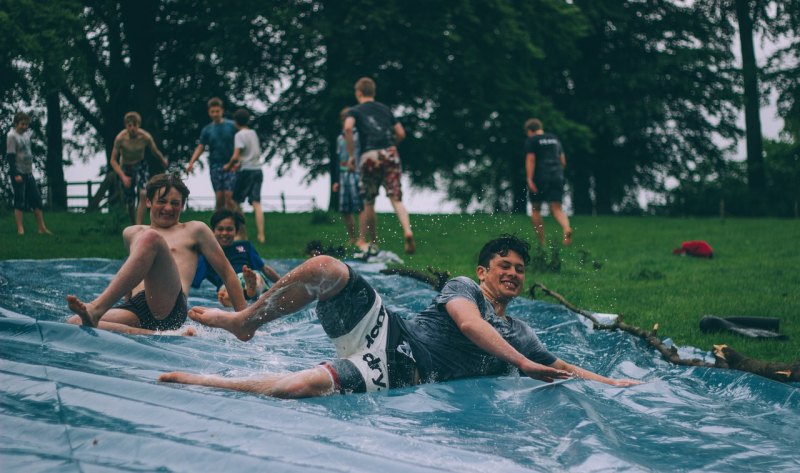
[317,266,416,394]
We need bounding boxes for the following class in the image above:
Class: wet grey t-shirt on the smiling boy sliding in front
[402,276,556,383]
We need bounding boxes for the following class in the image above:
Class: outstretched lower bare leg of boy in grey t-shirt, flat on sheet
[158,367,334,399]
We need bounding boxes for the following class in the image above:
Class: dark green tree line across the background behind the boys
[0,0,800,215]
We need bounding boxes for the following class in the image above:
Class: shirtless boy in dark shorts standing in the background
[110,112,169,225]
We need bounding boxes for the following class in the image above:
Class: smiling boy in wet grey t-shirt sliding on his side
[159,235,640,398]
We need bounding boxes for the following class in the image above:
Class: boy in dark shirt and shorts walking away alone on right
[525,118,572,245]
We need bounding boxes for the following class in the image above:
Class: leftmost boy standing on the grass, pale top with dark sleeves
[6,112,52,235]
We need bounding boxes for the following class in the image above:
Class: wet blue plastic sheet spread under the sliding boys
[0,259,800,473]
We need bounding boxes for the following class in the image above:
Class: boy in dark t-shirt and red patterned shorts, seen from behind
[344,77,416,254]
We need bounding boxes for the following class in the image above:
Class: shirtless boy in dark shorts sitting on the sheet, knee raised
[67,174,247,335]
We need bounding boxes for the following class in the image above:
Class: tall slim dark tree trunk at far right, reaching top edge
[736,0,767,214]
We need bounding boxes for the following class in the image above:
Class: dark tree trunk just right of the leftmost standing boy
[45,87,67,210]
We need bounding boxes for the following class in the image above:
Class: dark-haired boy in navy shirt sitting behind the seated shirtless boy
[192,209,280,307]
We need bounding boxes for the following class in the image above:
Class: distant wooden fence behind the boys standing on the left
[66,180,318,213]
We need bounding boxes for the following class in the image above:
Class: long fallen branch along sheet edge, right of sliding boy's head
[530,283,800,382]
